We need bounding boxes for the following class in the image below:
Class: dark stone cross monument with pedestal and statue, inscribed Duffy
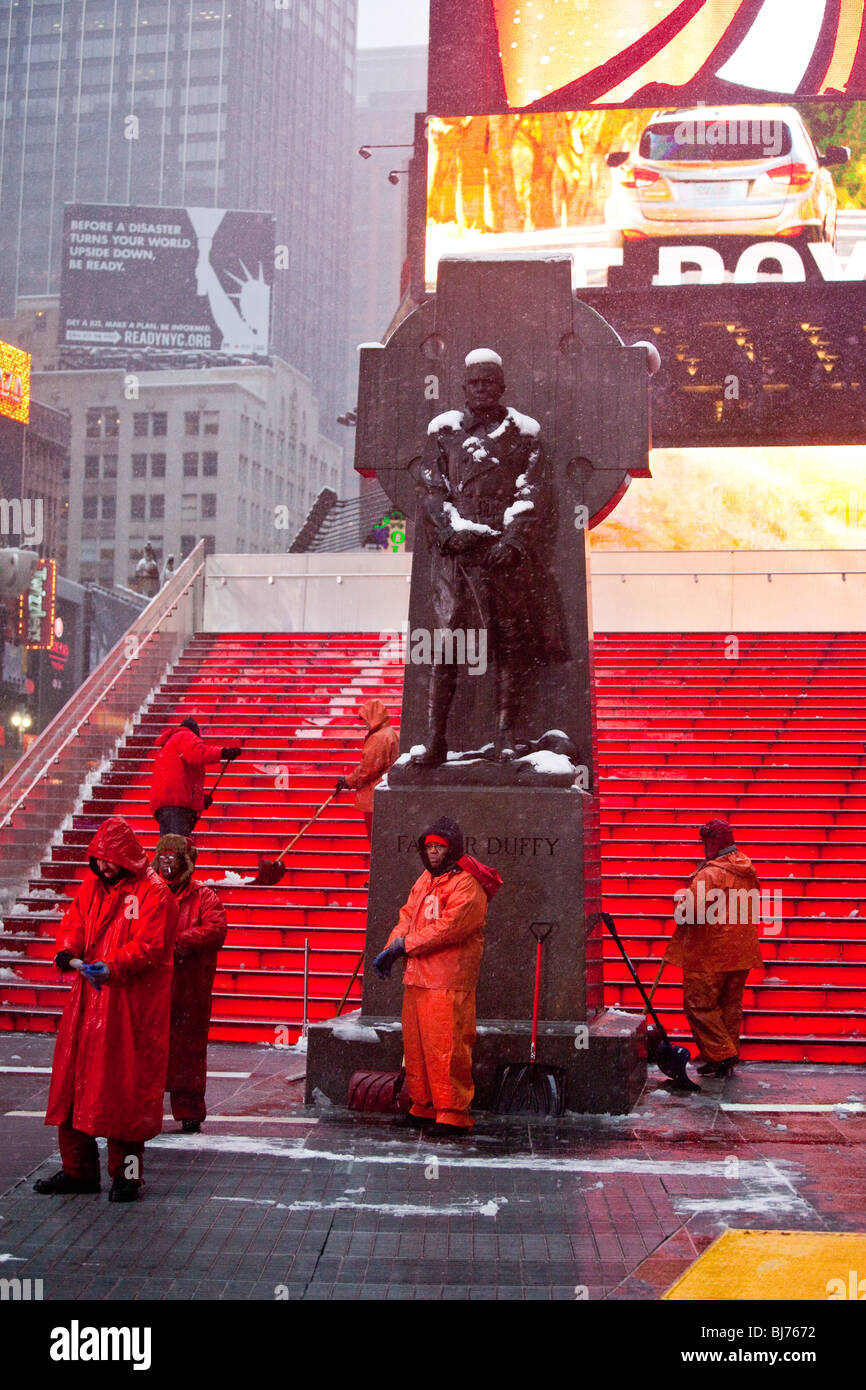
[307,256,649,1111]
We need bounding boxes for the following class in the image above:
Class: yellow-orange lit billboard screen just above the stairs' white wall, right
[589,446,866,550]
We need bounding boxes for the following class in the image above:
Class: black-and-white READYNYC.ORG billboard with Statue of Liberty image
[60,203,275,357]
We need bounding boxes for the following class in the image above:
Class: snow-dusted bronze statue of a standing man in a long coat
[413,348,569,767]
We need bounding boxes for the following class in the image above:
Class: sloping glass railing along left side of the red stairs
[0,542,204,909]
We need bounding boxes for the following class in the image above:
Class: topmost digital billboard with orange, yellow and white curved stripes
[430,0,866,115]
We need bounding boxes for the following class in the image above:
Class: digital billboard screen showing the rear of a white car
[425,101,866,289]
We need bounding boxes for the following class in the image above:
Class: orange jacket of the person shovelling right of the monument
[664,849,763,974]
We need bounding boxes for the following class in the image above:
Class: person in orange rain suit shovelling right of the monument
[664,820,763,1076]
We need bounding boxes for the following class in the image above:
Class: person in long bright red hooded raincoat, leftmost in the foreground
[36,816,178,1202]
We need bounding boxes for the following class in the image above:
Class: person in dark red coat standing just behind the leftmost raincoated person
[153,835,227,1134]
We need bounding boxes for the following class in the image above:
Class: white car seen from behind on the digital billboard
[605,106,851,275]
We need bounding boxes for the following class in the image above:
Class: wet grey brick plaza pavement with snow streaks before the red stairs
[0,1033,866,1301]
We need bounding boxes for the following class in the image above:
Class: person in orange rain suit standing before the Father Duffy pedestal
[373,816,502,1137]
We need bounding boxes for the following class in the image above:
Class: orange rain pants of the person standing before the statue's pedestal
[403,984,475,1129]
